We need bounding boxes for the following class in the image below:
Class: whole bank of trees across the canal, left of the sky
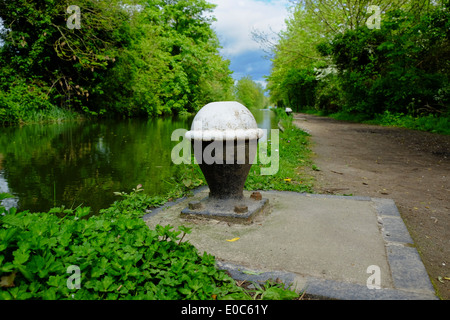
[0,0,233,122]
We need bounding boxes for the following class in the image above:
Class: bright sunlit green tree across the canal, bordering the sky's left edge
[98,0,233,116]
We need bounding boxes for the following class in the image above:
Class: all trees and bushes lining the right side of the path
[268,0,450,132]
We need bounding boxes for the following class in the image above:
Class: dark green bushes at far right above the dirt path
[326,6,450,117]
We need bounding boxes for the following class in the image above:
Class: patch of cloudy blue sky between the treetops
[209,0,289,86]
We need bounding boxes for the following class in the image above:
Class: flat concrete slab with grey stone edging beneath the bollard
[144,188,436,300]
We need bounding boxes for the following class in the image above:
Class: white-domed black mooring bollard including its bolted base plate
[182,101,267,222]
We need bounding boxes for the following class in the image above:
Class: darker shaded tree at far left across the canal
[0,0,135,116]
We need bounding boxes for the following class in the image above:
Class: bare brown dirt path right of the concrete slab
[294,114,450,300]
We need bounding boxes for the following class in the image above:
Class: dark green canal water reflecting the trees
[0,109,277,212]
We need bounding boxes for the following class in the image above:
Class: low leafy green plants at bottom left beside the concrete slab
[0,193,247,300]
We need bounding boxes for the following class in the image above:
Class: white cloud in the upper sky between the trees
[210,0,289,58]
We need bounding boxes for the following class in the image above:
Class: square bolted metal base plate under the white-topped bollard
[181,197,269,224]
